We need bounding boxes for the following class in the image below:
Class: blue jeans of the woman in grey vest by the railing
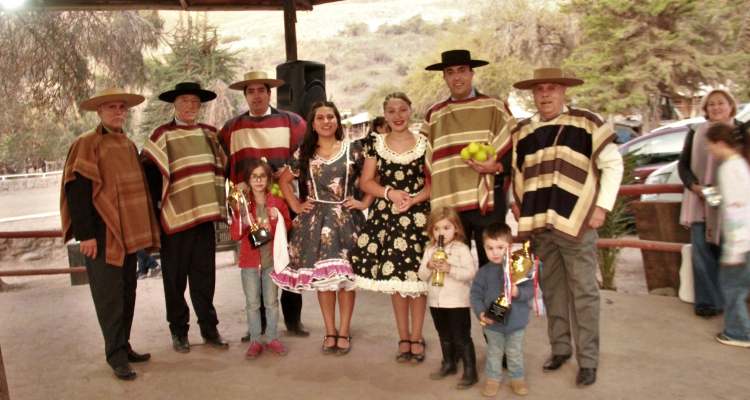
[690,222,724,311]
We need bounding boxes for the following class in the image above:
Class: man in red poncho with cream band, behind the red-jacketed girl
[219,71,309,342]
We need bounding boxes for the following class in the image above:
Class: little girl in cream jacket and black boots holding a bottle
[419,207,477,389]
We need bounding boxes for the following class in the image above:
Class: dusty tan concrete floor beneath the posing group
[0,267,750,400]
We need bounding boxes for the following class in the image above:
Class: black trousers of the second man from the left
[161,222,219,337]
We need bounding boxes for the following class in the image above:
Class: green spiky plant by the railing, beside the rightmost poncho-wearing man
[597,153,641,290]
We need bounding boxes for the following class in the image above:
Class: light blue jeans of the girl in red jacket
[240,267,279,342]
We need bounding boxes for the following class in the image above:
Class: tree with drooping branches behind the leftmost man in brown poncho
[0,11,162,170]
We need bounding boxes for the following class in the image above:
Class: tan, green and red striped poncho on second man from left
[142,121,226,234]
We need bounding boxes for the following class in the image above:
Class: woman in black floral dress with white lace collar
[352,93,430,362]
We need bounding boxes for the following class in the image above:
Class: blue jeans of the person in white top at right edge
[719,253,750,340]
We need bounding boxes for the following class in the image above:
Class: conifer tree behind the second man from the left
[141,13,240,144]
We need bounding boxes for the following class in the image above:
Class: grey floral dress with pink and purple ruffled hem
[271,141,365,292]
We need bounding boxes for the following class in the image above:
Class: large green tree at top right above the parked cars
[564,0,750,126]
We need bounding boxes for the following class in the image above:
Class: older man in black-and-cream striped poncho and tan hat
[512,68,623,386]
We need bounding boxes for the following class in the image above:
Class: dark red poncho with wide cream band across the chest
[219,107,307,183]
